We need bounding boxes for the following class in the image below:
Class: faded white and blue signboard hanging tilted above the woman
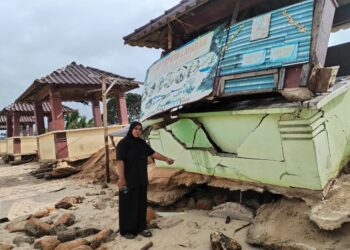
[141,26,226,120]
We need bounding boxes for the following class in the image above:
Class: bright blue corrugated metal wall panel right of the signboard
[220,0,314,76]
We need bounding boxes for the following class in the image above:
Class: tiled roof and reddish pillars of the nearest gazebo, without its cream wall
[16,62,139,135]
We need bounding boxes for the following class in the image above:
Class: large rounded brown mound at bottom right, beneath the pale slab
[246,199,350,250]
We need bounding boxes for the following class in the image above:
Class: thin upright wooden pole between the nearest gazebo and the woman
[101,76,111,183]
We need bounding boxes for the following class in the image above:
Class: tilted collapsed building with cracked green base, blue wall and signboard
[124,0,350,193]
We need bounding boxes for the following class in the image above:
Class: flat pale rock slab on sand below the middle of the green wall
[209,202,254,222]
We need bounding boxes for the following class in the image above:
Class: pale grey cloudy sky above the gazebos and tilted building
[0,0,350,117]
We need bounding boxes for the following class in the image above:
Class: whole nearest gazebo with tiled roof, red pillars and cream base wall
[16,62,140,160]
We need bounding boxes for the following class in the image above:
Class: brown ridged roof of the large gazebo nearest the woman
[34,62,139,88]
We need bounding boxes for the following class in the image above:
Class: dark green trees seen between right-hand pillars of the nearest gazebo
[107,93,141,124]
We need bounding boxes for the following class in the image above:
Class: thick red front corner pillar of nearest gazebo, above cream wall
[50,88,64,131]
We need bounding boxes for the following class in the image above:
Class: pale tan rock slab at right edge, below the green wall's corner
[309,175,350,230]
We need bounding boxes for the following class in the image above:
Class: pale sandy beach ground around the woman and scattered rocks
[0,160,259,250]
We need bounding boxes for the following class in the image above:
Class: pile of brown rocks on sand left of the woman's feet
[0,196,117,250]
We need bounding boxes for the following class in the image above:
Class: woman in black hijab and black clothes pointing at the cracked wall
[116,122,174,239]
